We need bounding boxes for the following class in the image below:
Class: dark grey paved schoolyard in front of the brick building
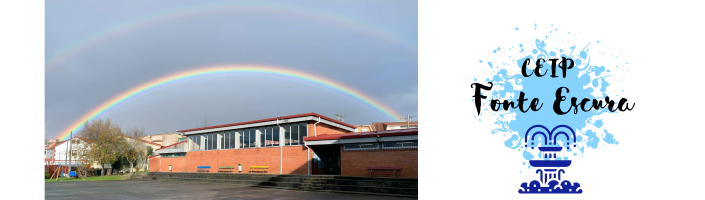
[44,181,416,200]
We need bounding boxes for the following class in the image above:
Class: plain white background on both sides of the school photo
[0,1,705,199]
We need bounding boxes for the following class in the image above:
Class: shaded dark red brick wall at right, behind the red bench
[340,147,419,178]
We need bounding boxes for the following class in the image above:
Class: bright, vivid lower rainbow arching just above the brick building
[59,65,401,140]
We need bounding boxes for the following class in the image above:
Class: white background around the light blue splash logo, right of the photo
[419,1,705,199]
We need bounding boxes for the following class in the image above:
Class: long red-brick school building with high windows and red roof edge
[149,113,418,178]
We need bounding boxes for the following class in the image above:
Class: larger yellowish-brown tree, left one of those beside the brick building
[79,119,125,175]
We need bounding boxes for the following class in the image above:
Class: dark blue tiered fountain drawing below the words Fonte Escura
[519,125,583,194]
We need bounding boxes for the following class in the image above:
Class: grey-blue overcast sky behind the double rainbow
[45,0,418,138]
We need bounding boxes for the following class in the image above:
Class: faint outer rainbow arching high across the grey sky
[46,2,417,71]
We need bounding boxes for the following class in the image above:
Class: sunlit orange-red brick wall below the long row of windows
[149,146,313,174]
